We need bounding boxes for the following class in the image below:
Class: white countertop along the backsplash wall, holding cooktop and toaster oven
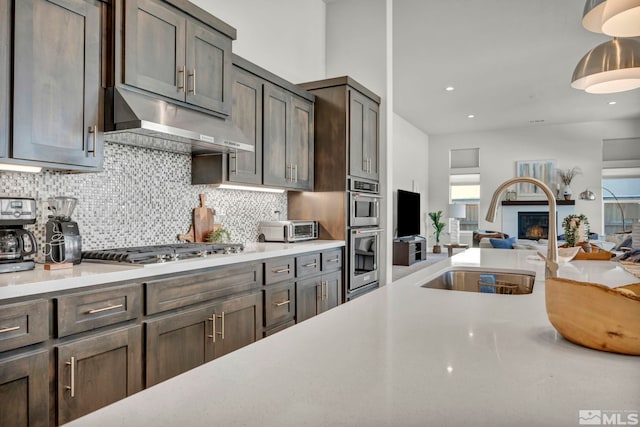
[0,240,344,301]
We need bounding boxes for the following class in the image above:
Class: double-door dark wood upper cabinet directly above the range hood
[123,0,232,116]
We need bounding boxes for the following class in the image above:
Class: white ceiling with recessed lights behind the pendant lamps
[393,0,640,135]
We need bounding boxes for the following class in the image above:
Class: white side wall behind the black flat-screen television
[391,113,430,236]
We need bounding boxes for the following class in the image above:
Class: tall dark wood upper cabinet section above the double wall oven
[300,76,380,191]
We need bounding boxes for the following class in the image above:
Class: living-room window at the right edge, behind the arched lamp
[602,177,640,234]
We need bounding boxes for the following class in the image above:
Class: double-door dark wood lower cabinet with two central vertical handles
[145,293,262,387]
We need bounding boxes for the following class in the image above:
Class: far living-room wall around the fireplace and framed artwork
[429,119,640,234]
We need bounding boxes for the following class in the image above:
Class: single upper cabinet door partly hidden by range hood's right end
[228,67,263,184]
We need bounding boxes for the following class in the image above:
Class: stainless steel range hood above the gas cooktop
[105,87,254,154]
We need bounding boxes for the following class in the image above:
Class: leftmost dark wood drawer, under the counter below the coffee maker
[0,299,49,352]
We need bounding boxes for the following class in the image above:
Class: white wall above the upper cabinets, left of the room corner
[190,0,325,83]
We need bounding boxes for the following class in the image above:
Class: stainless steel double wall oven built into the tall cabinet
[345,178,382,300]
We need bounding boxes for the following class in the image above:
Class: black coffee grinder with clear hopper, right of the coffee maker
[45,197,82,264]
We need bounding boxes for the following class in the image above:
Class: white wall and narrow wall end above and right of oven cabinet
[326,0,393,285]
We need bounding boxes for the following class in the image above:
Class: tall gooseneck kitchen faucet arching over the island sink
[486,177,558,278]
